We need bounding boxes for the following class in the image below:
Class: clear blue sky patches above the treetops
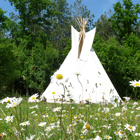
[0,0,140,21]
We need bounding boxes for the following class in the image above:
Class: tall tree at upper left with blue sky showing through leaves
[9,0,57,46]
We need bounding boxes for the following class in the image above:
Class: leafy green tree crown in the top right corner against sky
[110,0,140,42]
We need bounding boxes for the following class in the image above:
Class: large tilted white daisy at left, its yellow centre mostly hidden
[6,97,22,108]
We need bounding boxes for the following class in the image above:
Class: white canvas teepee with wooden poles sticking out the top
[42,18,121,103]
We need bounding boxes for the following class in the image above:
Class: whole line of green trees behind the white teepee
[0,0,140,98]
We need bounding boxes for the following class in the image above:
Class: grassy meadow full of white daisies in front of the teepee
[0,94,140,140]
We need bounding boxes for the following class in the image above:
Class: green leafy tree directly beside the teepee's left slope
[16,39,59,96]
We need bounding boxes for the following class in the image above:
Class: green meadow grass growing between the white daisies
[0,99,140,140]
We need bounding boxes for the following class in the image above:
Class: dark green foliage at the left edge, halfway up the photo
[0,40,20,97]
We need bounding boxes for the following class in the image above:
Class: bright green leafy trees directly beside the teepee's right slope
[93,35,140,97]
